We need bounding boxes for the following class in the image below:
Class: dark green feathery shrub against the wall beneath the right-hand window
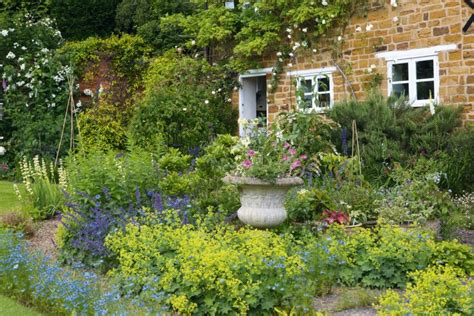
[329,95,474,192]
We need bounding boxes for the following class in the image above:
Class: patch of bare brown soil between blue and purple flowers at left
[28,219,59,260]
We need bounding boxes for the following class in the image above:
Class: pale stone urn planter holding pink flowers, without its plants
[223,176,304,228]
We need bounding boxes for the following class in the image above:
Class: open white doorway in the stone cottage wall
[239,74,267,137]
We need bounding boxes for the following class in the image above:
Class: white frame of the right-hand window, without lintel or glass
[387,55,439,107]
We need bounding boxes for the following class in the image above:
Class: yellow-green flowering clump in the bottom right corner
[376,266,474,315]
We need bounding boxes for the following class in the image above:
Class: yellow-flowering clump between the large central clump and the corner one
[327,226,433,288]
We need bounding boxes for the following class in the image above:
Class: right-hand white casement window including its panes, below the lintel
[387,56,439,106]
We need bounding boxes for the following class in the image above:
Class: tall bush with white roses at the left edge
[0,14,71,163]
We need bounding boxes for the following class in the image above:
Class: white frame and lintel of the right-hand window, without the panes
[375,44,458,107]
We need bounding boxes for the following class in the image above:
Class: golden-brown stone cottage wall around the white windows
[233,0,474,123]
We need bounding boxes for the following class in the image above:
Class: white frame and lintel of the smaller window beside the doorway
[287,67,336,113]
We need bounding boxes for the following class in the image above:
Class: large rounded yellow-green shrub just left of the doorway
[130,55,236,152]
